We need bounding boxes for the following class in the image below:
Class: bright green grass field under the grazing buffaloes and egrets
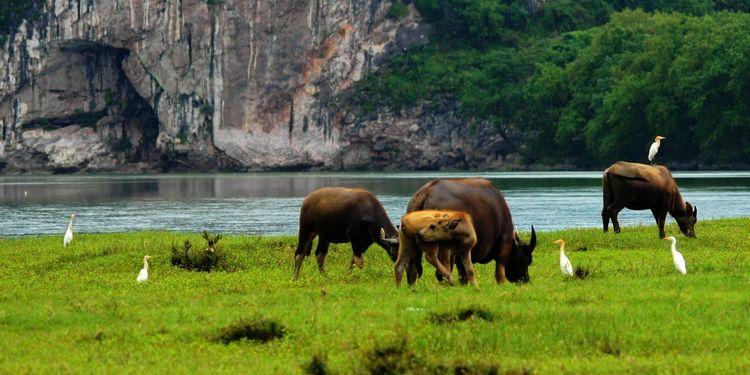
[0,219,750,373]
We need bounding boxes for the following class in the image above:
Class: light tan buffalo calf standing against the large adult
[390,210,477,287]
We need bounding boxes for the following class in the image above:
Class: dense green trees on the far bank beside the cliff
[356,0,750,167]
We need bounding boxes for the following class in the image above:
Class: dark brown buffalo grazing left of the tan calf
[294,188,398,279]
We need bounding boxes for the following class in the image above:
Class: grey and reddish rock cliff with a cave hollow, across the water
[0,0,516,172]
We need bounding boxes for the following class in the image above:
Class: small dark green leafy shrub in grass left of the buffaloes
[171,231,227,272]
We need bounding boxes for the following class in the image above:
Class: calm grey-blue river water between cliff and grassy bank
[0,172,750,236]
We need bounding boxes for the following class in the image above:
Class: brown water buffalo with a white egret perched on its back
[602,161,698,238]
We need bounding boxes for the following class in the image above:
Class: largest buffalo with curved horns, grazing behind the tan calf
[406,178,536,284]
